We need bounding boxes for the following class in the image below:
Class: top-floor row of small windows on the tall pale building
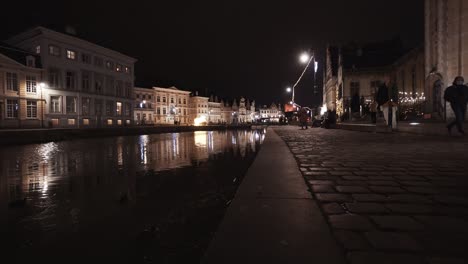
[40,45,132,74]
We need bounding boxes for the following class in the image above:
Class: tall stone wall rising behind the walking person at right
[424,0,468,118]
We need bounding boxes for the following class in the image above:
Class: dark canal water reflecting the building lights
[0,130,265,263]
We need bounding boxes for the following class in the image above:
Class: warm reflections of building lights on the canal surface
[0,131,264,260]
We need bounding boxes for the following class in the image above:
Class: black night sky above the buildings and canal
[0,0,424,105]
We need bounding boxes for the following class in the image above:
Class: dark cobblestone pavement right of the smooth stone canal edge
[274,127,468,264]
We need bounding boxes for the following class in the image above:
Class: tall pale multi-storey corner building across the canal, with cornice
[7,27,136,128]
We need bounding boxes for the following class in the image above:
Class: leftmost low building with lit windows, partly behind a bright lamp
[0,44,44,128]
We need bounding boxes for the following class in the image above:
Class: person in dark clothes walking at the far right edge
[444,76,468,135]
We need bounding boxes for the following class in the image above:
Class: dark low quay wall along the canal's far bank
[0,125,260,145]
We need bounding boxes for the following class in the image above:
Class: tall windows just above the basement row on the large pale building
[49,96,132,116]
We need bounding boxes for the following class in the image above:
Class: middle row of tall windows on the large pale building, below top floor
[48,68,132,98]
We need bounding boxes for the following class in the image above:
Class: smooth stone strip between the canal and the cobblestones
[202,129,345,264]
